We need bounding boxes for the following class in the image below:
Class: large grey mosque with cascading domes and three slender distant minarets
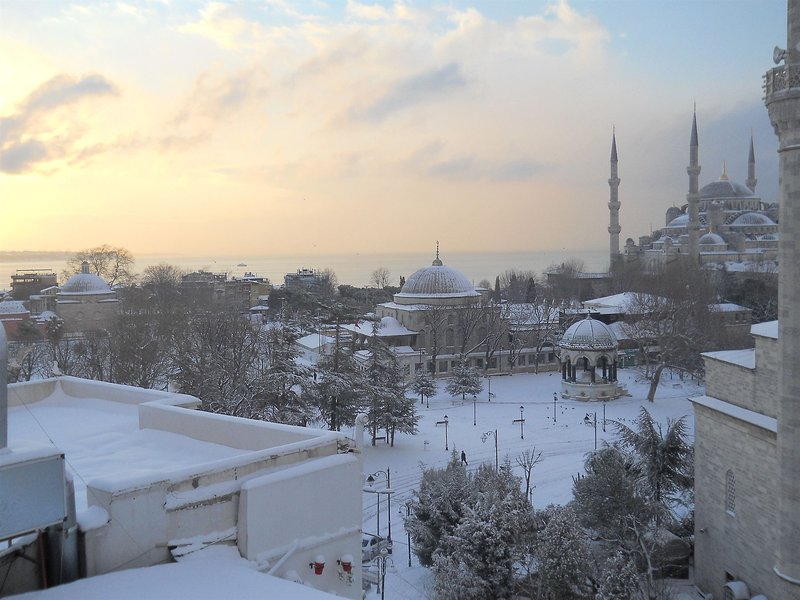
[608,118,778,268]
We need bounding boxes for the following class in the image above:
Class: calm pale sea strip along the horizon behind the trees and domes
[0,249,609,289]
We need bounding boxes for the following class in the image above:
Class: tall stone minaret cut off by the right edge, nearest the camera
[764,0,800,598]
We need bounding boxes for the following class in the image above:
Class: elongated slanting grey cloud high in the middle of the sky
[349,63,467,121]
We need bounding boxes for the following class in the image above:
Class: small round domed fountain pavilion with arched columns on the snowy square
[559,315,625,400]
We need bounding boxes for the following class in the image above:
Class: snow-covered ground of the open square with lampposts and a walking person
[363,369,702,600]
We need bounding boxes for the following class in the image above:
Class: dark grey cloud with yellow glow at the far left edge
[0,74,118,174]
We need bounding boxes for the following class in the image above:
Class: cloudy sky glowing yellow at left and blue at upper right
[0,0,786,256]
